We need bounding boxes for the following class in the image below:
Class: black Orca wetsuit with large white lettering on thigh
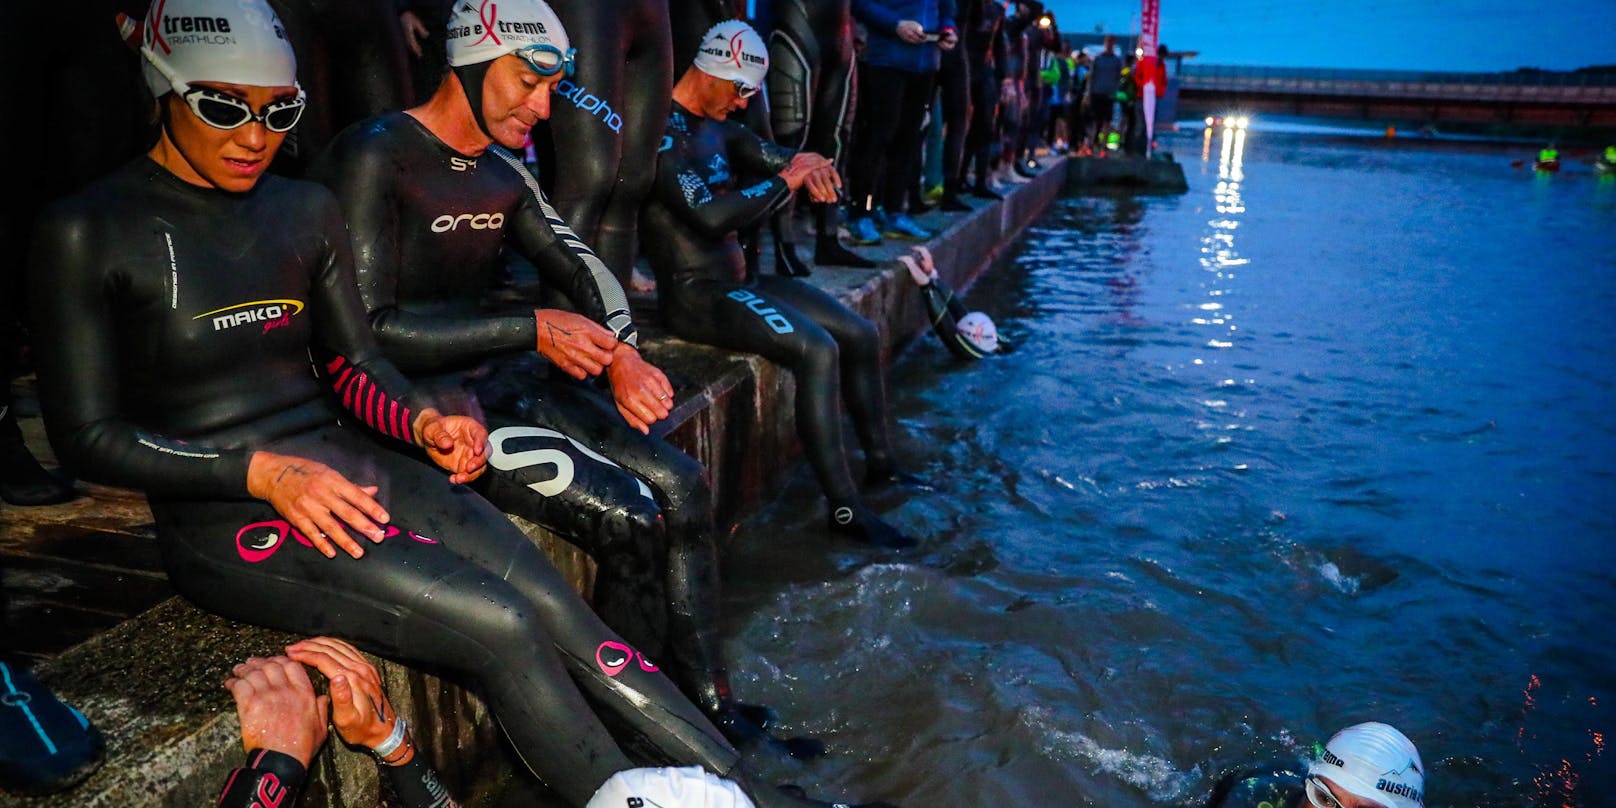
[317,113,729,711]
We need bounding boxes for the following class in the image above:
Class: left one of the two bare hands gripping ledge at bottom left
[225,656,331,769]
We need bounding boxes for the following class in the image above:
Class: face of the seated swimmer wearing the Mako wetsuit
[150,81,297,194]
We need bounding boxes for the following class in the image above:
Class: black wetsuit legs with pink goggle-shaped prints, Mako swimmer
[152,428,735,805]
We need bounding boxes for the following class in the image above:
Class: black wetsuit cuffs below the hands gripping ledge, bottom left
[215,750,459,808]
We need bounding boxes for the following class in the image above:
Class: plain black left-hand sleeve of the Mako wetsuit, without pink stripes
[29,200,249,498]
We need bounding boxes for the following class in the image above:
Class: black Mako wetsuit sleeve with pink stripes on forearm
[310,189,419,443]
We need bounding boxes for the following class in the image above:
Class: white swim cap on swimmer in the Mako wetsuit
[141,0,297,97]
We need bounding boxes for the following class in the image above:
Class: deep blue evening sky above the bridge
[1046,0,1616,71]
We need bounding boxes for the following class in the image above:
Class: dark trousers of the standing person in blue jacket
[848,63,937,210]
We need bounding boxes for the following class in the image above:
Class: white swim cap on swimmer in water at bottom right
[1307,721,1425,808]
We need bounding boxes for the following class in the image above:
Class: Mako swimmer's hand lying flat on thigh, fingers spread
[247,451,391,558]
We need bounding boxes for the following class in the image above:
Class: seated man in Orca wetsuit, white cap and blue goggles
[317,0,814,753]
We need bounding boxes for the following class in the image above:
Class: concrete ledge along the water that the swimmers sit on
[15,158,1067,808]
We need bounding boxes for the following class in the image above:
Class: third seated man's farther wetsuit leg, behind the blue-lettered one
[758,278,897,478]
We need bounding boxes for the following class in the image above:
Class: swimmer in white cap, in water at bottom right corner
[1207,721,1425,808]
